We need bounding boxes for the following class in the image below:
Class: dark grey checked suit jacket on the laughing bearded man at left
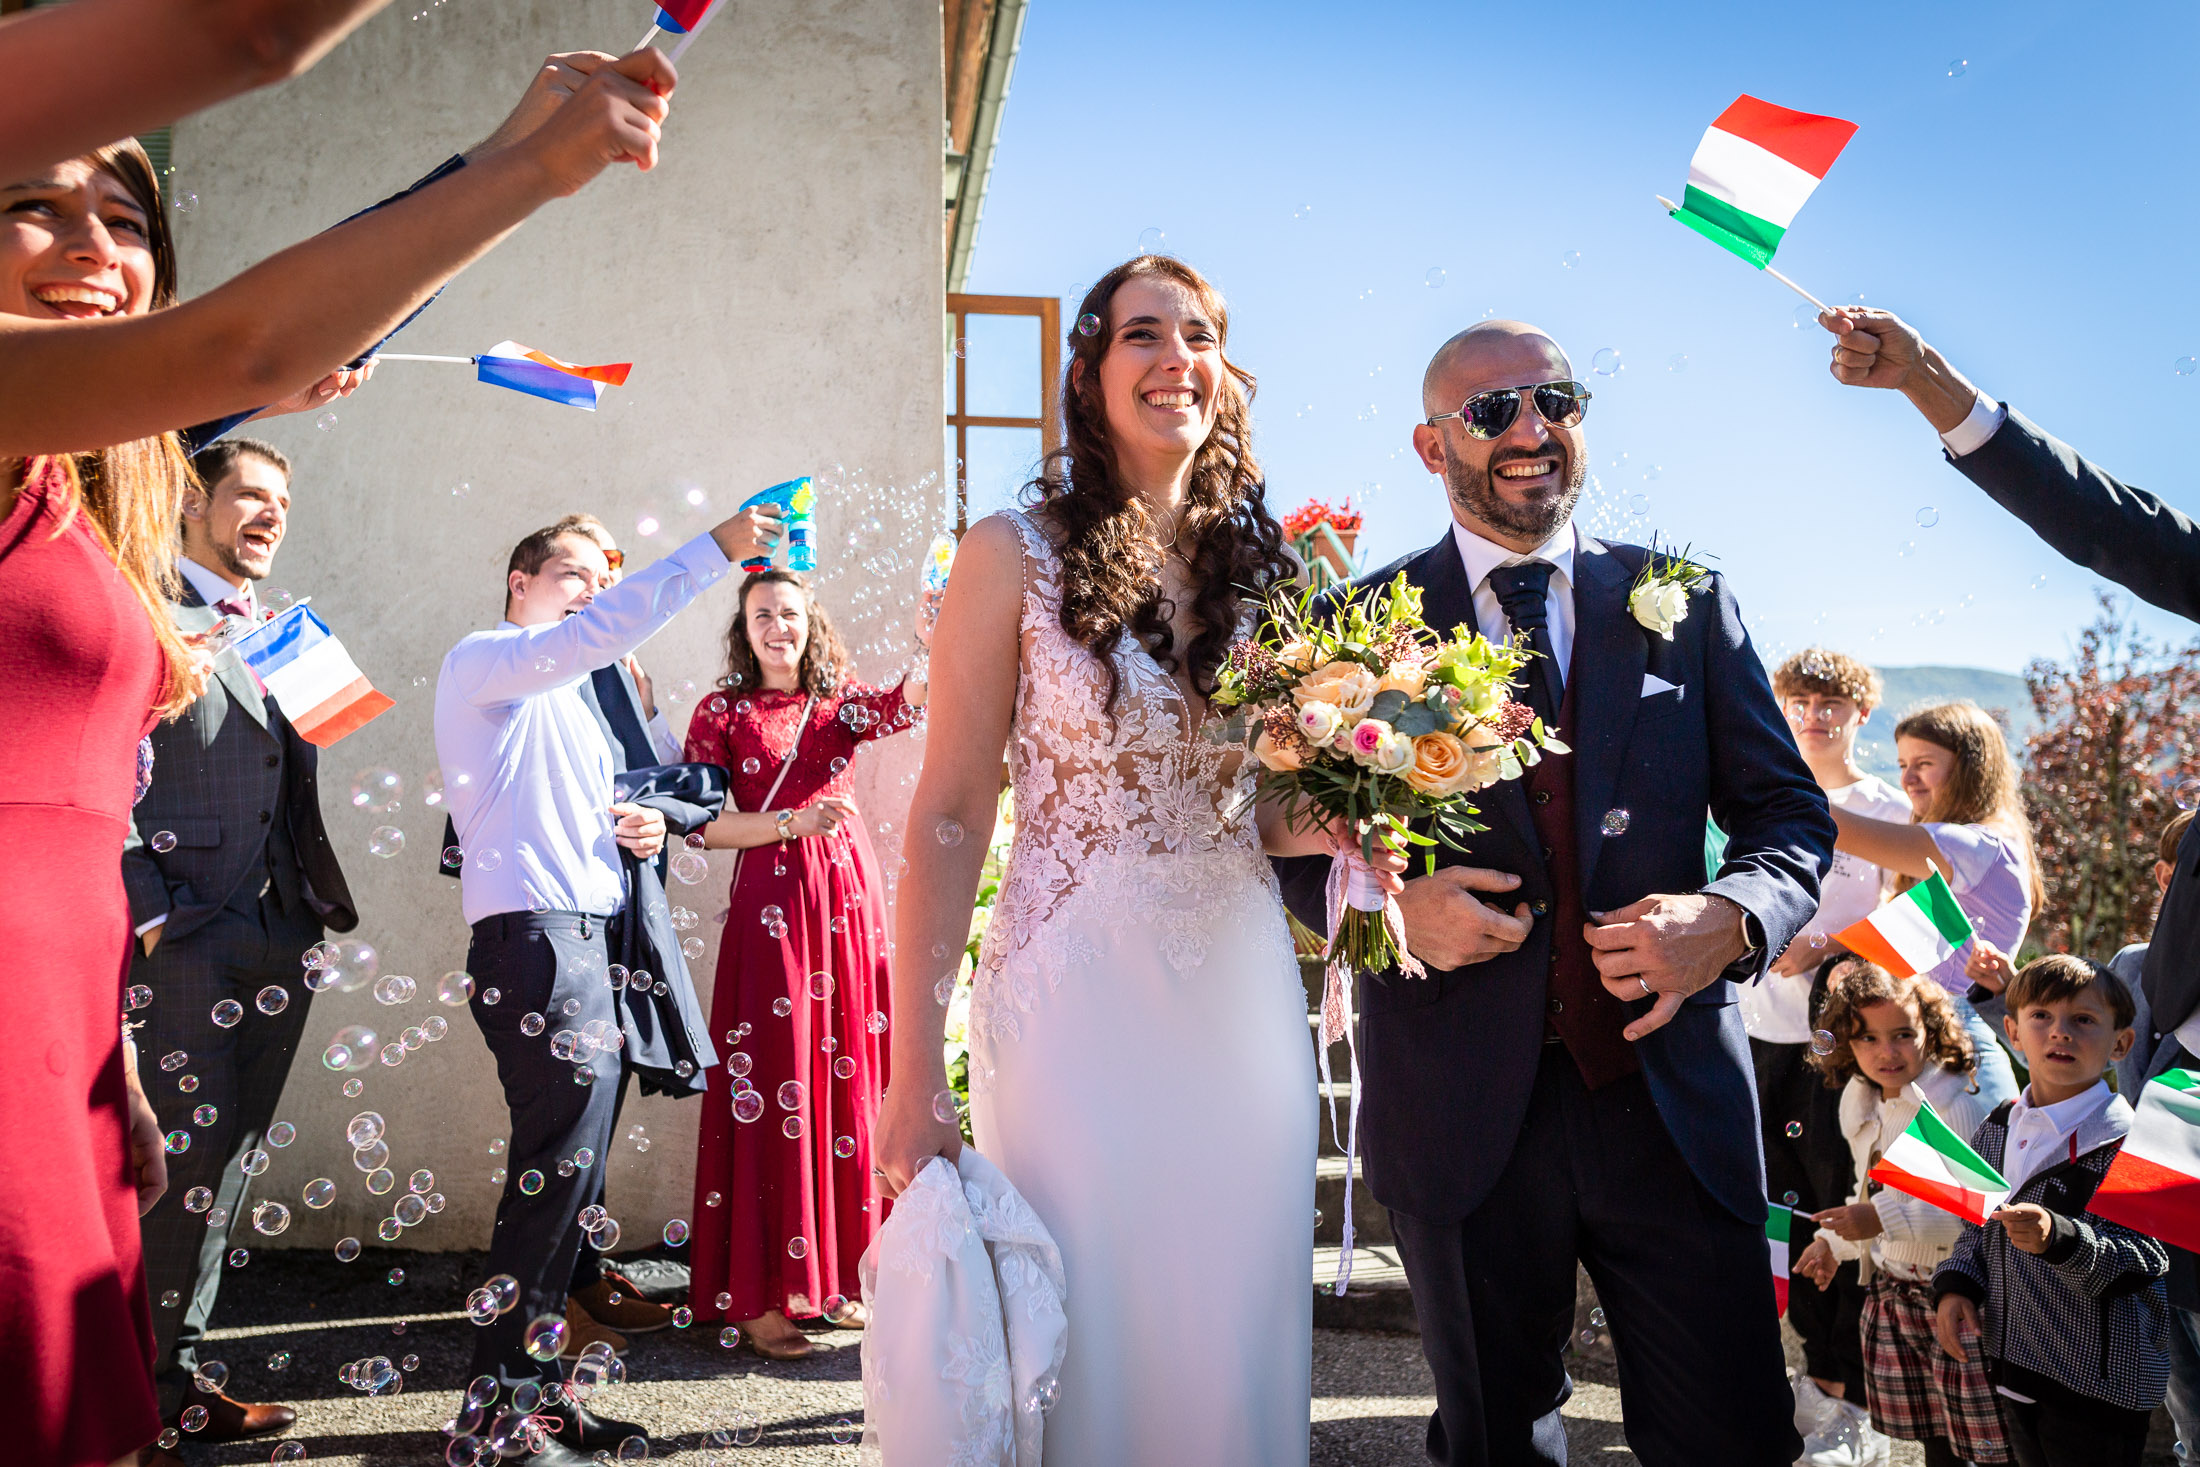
[123,583,359,941]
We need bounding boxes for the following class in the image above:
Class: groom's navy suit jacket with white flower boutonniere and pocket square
[1276,534,1835,1225]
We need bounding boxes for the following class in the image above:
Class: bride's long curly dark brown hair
[1023,255,1298,708]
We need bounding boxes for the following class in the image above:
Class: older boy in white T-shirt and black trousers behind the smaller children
[1740,647,1910,1467]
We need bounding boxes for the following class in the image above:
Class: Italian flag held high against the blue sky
[1672,97,1857,271]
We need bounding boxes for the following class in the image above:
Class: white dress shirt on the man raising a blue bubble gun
[436,534,730,924]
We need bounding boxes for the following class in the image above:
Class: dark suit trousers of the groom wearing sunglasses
[1390,1045,1802,1467]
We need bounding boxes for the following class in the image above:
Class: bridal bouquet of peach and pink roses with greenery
[1210,574,1566,972]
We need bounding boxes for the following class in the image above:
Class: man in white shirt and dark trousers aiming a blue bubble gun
[436,508,779,1467]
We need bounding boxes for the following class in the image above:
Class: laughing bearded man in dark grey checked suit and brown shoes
[123,438,359,1460]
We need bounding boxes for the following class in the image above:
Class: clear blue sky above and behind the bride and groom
[968,0,2200,671]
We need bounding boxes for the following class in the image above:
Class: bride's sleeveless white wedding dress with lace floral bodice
[970,512,1316,1467]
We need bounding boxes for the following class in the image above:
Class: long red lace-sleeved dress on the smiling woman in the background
[686,686,920,1320]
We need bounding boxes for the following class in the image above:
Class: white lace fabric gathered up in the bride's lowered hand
[856,1146,1069,1467]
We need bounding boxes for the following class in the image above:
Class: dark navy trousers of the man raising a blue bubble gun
[466,913,627,1392]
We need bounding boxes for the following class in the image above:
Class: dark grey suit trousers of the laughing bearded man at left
[130,895,321,1416]
